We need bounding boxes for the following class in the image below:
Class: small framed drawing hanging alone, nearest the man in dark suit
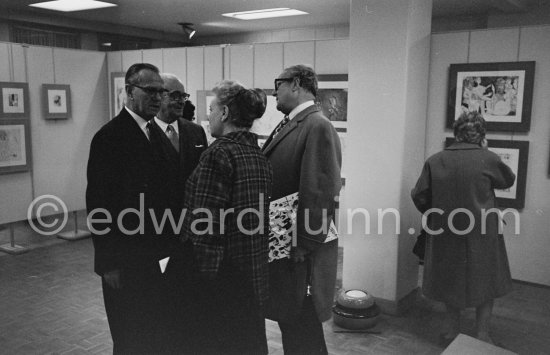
[42,84,71,120]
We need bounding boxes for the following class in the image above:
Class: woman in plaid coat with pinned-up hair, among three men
[183,80,272,354]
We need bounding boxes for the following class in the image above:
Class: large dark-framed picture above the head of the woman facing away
[447,61,535,132]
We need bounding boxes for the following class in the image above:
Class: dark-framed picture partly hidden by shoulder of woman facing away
[445,138,529,209]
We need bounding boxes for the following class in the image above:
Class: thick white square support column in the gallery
[343,0,434,313]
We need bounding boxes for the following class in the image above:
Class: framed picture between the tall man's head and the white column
[315,74,348,132]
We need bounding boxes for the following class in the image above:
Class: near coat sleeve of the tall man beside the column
[297,119,342,251]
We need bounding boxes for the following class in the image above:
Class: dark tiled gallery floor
[0,224,550,355]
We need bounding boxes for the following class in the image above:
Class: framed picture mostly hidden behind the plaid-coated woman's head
[196,89,284,147]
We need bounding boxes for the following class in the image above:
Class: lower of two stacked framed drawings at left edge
[0,119,31,174]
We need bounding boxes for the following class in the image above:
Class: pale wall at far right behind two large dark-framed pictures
[426,26,550,285]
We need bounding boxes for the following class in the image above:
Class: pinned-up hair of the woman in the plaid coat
[212,80,267,128]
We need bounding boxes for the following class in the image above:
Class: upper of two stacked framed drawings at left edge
[0,82,29,118]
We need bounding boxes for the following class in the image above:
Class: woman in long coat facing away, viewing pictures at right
[411,112,515,343]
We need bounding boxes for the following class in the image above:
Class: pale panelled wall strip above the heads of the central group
[107,39,349,101]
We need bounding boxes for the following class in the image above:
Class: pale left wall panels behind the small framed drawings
[0,43,109,228]
